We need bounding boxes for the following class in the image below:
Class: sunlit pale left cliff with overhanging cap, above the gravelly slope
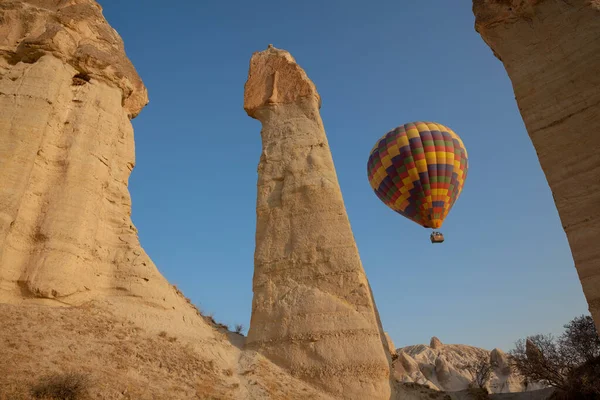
[0,0,234,350]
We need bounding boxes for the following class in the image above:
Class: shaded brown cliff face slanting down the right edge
[473,0,600,331]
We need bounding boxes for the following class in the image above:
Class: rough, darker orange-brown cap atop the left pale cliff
[0,0,148,117]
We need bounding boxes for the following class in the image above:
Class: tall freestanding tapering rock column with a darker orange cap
[244,46,391,400]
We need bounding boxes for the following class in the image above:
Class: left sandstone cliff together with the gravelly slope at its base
[0,0,342,400]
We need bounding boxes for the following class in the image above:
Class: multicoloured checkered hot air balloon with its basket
[367,121,469,243]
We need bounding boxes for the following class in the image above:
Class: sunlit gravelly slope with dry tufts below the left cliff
[0,304,338,400]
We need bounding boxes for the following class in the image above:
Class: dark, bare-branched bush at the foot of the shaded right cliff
[509,315,600,394]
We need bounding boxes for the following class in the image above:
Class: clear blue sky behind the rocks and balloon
[100,0,587,350]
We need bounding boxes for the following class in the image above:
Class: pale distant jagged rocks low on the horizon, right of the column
[393,336,544,393]
